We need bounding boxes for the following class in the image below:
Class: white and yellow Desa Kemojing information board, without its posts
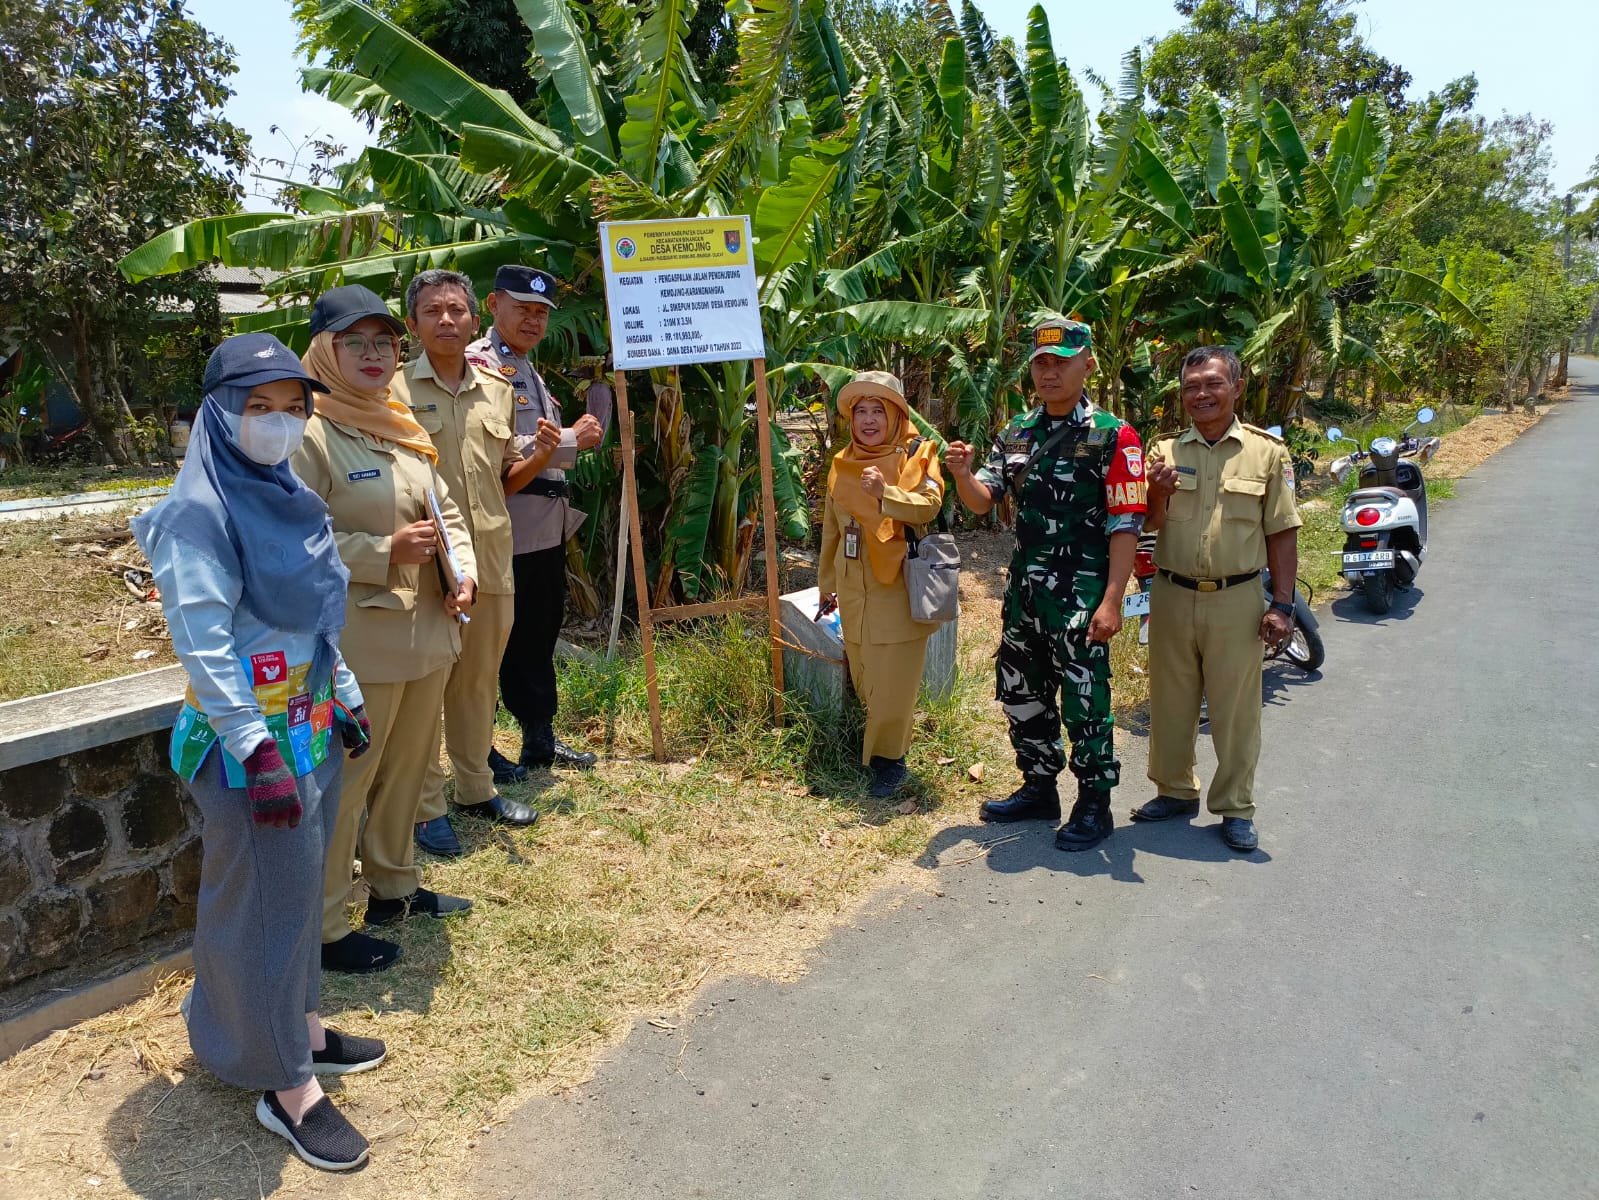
[600,216,766,371]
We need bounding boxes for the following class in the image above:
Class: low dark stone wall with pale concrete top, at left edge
[0,672,200,1008]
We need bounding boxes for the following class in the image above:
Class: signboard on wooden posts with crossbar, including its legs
[600,216,784,762]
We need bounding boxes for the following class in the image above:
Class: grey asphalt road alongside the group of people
[478,363,1599,1200]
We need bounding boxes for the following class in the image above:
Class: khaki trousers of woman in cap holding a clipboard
[321,667,449,942]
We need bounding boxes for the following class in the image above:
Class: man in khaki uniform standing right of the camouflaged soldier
[1132,346,1300,851]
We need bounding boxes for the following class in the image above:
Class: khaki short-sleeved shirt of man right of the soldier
[1150,419,1300,579]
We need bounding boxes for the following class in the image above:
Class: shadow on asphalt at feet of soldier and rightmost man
[916,808,1271,883]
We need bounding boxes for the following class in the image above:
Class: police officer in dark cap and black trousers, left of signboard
[467,266,609,782]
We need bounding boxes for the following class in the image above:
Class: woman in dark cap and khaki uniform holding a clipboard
[294,285,477,973]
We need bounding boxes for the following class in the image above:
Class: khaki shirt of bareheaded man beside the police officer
[393,354,521,595]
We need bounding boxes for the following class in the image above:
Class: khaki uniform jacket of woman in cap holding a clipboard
[294,416,478,683]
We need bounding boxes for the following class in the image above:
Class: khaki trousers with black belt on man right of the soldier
[1150,574,1266,819]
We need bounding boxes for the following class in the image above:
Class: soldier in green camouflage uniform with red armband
[945,320,1145,850]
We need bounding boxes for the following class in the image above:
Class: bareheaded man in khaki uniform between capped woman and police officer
[393,270,539,858]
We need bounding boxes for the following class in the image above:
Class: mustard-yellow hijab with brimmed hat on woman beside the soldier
[831,371,942,584]
